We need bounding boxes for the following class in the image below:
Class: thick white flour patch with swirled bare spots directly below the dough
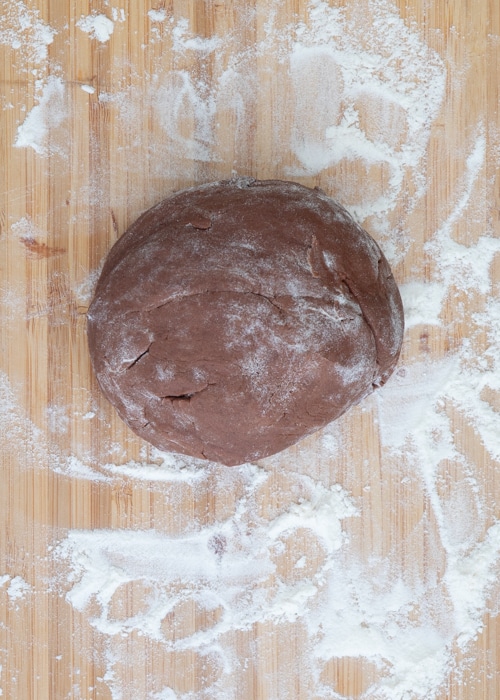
[57,474,357,644]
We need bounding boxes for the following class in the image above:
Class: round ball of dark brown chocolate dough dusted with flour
[88,178,403,465]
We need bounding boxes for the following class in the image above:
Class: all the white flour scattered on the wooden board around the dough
[0,0,500,700]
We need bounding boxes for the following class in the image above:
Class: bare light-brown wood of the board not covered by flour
[0,0,500,700]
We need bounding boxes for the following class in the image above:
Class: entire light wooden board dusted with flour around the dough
[0,0,500,700]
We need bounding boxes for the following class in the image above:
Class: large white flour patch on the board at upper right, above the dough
[290,0,444,198]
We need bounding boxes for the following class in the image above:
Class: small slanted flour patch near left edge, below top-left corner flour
[14,75,68,155]
